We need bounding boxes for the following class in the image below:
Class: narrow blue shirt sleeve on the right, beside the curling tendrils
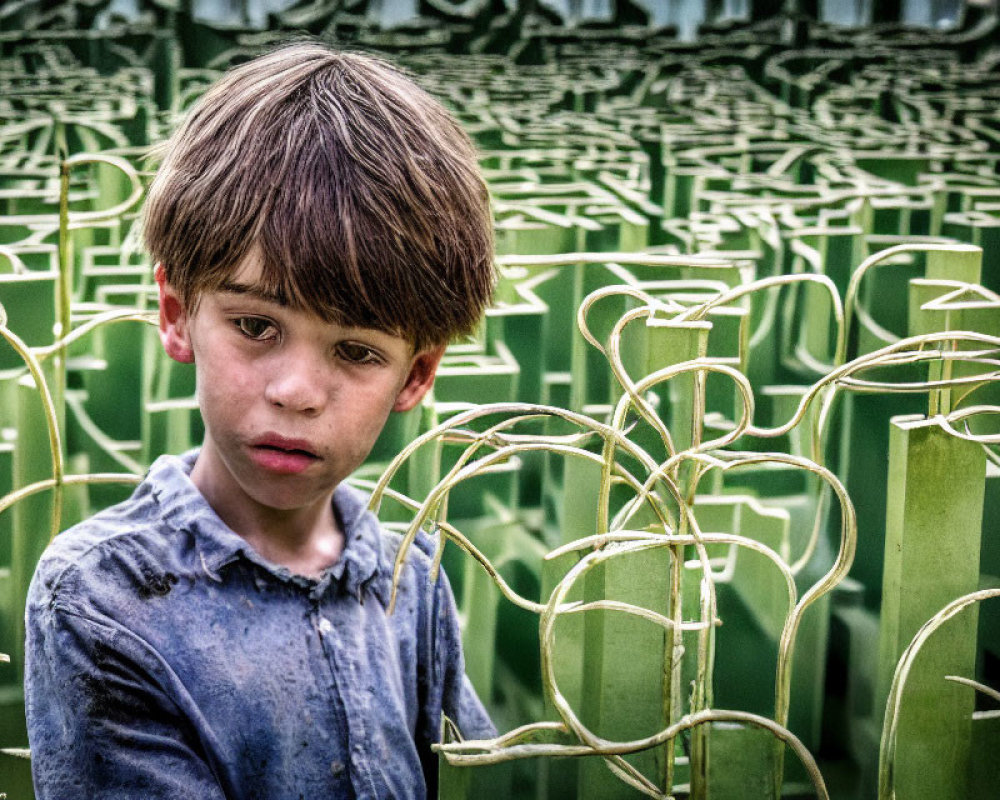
[418,569,497,797]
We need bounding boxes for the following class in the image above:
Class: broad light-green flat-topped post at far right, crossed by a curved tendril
[875,416,986,800]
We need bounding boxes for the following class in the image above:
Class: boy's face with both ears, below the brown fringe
[157,258,444,511]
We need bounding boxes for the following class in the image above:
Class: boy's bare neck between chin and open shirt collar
[191,448,344,578]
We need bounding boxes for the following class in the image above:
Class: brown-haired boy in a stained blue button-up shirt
[26,44,494,800]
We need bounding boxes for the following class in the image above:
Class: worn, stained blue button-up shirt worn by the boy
[25,453,493,800]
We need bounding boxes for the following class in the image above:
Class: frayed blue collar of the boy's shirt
[146,449,388,604]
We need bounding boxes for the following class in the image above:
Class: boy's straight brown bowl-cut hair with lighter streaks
[144,42,495,349]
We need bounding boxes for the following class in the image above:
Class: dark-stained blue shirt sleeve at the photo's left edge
[25,601,225,800]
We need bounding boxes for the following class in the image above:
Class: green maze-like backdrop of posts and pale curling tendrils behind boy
[0,0,1000,800]
